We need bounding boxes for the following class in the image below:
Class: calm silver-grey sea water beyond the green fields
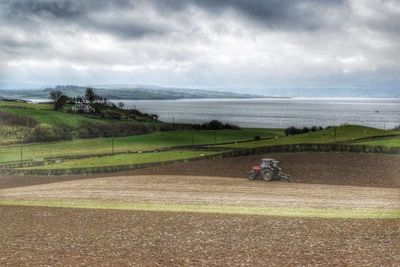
[114,98,400,129]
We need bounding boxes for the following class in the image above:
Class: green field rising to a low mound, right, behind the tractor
[214,125,400,148]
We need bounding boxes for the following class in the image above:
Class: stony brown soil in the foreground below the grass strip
[0,206,400,266]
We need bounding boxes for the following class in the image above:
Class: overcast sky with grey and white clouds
[0,0,400,92]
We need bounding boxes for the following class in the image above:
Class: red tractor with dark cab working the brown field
[248,159,292,182]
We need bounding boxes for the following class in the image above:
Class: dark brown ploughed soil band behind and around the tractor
[0,153,400,189]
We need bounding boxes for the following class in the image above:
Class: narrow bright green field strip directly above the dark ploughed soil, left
[21,150,216,170]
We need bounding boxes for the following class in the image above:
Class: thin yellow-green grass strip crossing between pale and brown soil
[0,200,400,219]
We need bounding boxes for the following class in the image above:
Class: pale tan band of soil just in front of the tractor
[0,175,400,209]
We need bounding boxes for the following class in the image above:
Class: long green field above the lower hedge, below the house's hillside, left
[0,129,283,162]
